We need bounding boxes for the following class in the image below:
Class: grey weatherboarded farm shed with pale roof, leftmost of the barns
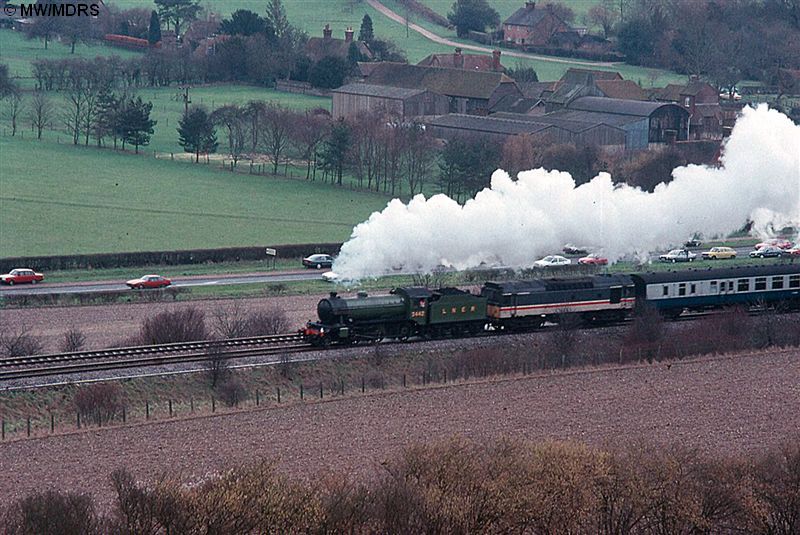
[331,83,449,119]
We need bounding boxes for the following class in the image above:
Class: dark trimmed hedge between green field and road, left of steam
[0,243,342,273]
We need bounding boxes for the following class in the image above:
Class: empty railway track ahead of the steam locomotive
[0,333,315,381]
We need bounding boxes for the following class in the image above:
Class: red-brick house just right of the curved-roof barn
[653,79,724,140]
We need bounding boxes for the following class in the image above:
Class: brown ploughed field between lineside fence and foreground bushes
[0,349,800,506]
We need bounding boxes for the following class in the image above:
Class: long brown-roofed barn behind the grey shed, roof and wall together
[366,62,523,115]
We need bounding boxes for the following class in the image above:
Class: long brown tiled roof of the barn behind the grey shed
[367,62,515,99]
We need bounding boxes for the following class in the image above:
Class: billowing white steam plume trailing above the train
[334,105,800,279]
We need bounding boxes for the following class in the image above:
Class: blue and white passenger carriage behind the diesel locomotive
[631,264,800,316]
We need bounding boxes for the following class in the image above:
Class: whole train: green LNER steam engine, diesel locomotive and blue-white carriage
[301,264,800,347]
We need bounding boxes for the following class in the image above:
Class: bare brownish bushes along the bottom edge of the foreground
[0,438,800,535]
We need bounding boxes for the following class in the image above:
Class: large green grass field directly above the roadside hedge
[0,137,387,257]
